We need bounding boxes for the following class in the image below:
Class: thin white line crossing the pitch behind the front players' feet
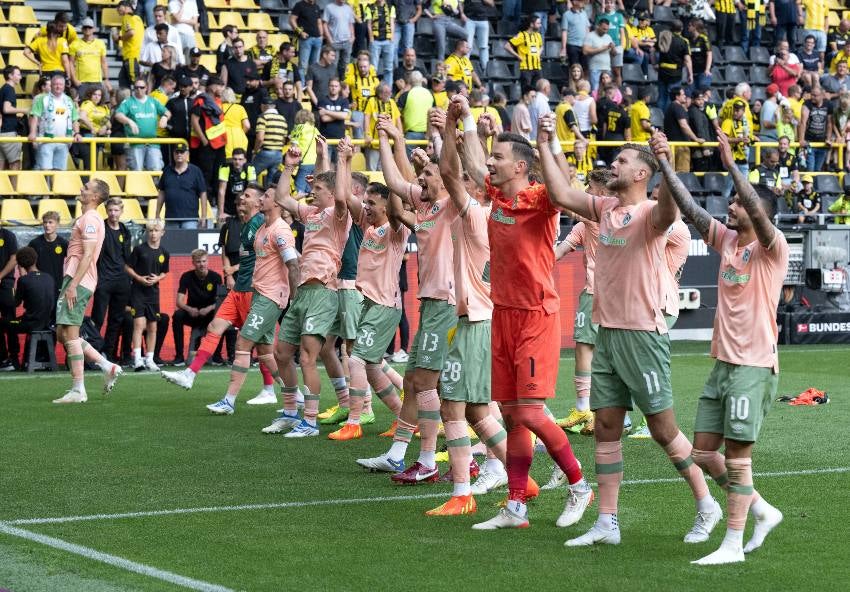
[9,467,850,525]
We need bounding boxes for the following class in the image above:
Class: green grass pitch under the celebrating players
[0,343,850,592]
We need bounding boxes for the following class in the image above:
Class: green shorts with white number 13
[405,298,457,372]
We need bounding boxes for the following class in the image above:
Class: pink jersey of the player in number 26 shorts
[357,211,411,308]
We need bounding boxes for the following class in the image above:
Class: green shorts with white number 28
[440,316,490,405]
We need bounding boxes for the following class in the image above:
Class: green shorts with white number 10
[694,360,779,442]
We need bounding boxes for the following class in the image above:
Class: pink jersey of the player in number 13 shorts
[408,183,457,304]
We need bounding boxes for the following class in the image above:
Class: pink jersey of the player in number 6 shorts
[295,204,351,290]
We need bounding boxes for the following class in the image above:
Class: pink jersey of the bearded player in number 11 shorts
[587,195,667,334]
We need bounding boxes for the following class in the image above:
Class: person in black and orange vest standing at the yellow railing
[189,76,227,194]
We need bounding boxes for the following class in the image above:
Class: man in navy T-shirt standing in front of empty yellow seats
[156,144,208,229]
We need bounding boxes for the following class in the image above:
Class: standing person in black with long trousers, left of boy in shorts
[91,197,132,362]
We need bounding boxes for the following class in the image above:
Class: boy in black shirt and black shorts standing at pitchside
[125,220,169,372]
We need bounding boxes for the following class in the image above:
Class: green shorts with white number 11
[590,327,673,415]
